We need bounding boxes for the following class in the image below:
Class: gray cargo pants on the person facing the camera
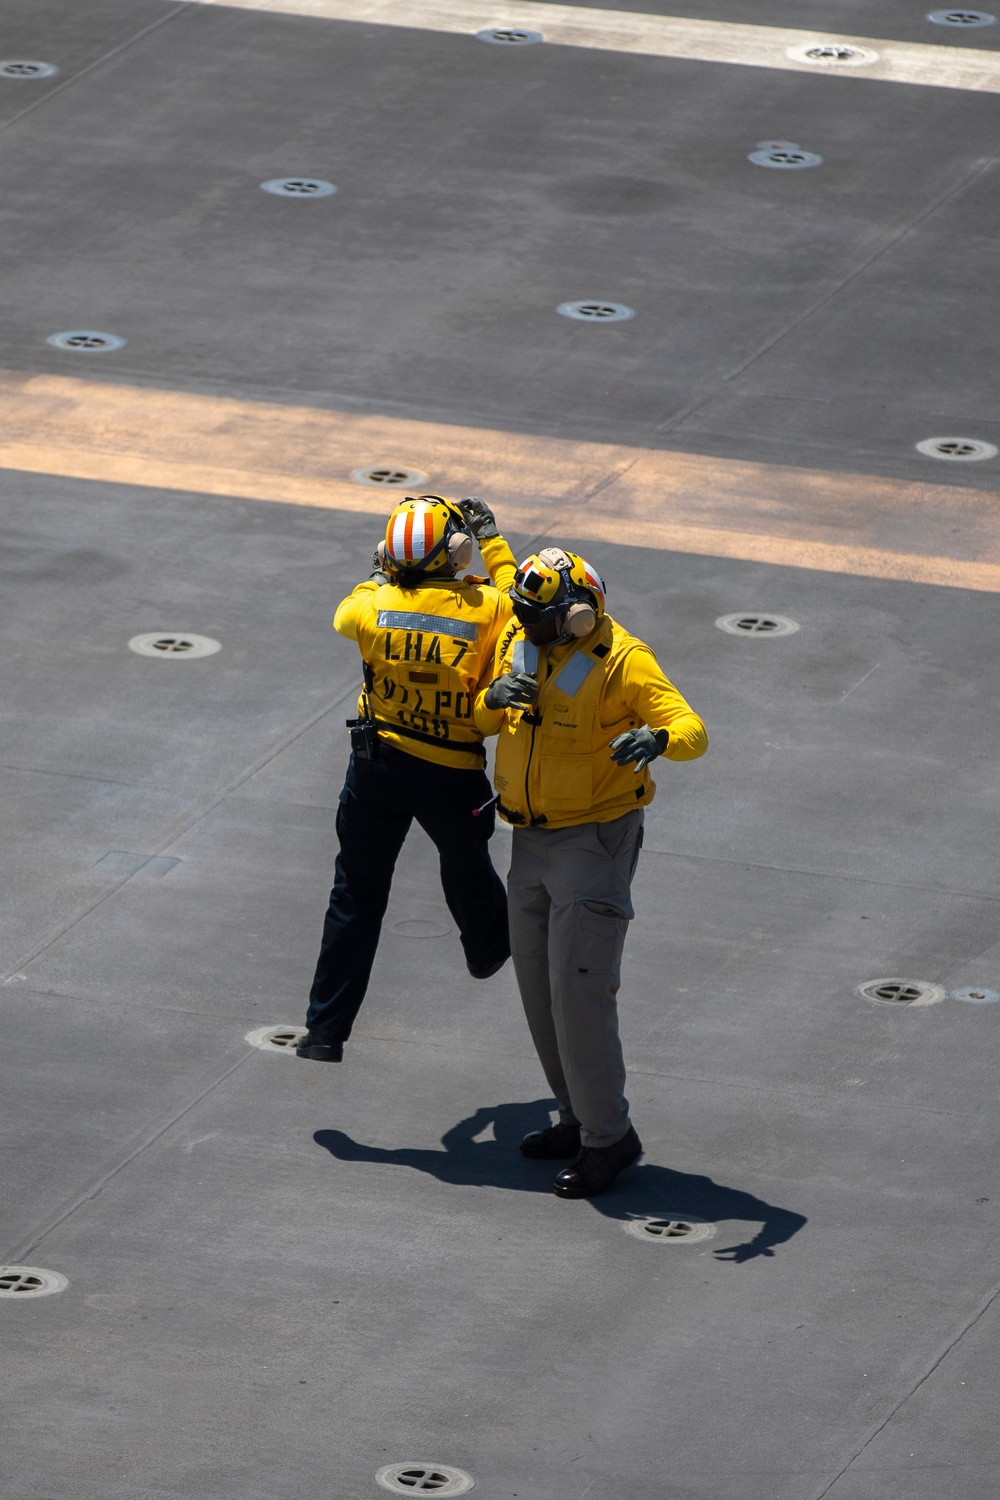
[507,810,643,1146]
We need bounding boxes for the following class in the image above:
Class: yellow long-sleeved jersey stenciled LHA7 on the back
[333,537,516,771]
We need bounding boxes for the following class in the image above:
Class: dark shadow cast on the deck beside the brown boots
[313,1100,807,1265]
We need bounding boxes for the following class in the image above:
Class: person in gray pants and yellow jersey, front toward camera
[475,548,708,1199]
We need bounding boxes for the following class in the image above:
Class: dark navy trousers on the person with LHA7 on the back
[306,744,510,1043]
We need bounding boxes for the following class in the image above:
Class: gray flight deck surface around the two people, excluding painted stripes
[0,0,1000,1500]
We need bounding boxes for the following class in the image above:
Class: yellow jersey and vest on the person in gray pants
[475,615,708,828]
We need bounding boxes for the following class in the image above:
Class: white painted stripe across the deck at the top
[190,0,1000,93]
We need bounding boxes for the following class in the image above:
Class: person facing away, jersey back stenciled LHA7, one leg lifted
[295,495,514,1062]
